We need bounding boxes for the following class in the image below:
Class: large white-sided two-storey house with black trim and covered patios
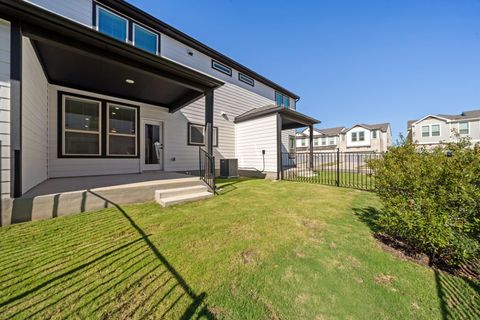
[0,0,318,212]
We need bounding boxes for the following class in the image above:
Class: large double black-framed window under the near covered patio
[58,92,140,158]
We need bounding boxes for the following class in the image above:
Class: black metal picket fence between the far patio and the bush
[281,151,383,190]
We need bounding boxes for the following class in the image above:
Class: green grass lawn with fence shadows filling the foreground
[0,180,480,319]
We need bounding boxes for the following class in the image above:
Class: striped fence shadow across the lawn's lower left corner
[0,191,215,319]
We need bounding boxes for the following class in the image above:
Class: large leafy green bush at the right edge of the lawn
[369,139,480,265]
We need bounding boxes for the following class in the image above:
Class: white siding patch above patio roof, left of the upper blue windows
[24,0,93,27]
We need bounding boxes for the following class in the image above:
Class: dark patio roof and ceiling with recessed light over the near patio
[0,0,223,112]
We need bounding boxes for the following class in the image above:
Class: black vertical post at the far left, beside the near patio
[10,21,22,198]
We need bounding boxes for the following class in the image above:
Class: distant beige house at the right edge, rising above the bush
[407,110,480,147]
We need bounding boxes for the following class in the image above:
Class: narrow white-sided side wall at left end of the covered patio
[22,38,48,192]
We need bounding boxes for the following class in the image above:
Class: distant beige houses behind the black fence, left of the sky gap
[296,123,392,152]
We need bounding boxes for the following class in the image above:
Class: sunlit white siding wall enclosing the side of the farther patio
[236,114,277,172]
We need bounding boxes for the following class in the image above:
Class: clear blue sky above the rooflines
[129,0,480,138]
